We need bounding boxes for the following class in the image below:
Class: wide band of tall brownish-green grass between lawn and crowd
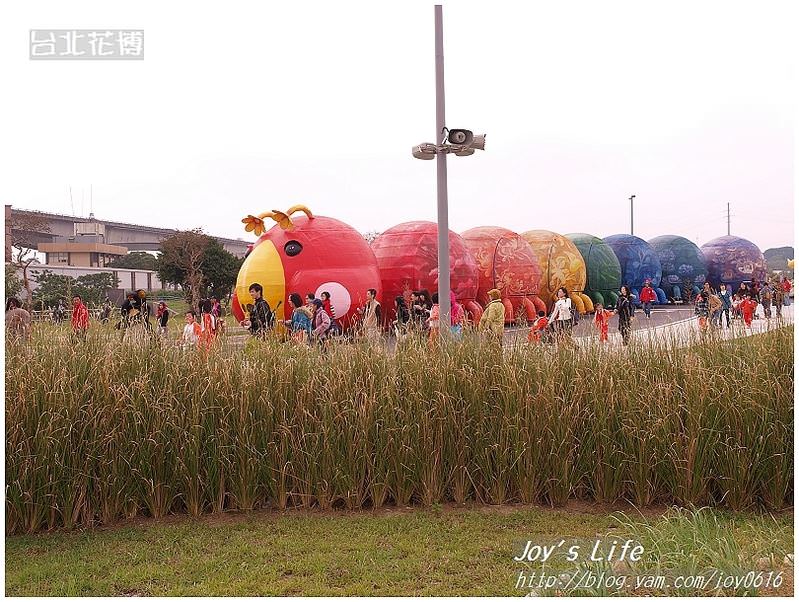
[6,327,794,533]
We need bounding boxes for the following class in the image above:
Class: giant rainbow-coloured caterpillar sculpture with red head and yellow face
[232,205,766,329]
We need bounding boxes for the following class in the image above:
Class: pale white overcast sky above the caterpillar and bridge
[0,0,797,249]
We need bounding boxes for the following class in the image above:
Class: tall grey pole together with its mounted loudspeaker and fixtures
[412,4,485,333]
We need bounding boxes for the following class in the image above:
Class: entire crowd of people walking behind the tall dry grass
[6,277,792,349]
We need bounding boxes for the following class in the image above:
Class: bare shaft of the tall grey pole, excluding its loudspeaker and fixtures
[435,4,451,333]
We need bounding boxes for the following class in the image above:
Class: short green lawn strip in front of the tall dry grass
[5,504,793,596]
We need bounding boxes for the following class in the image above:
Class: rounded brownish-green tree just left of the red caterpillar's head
[158,229,241,307]
